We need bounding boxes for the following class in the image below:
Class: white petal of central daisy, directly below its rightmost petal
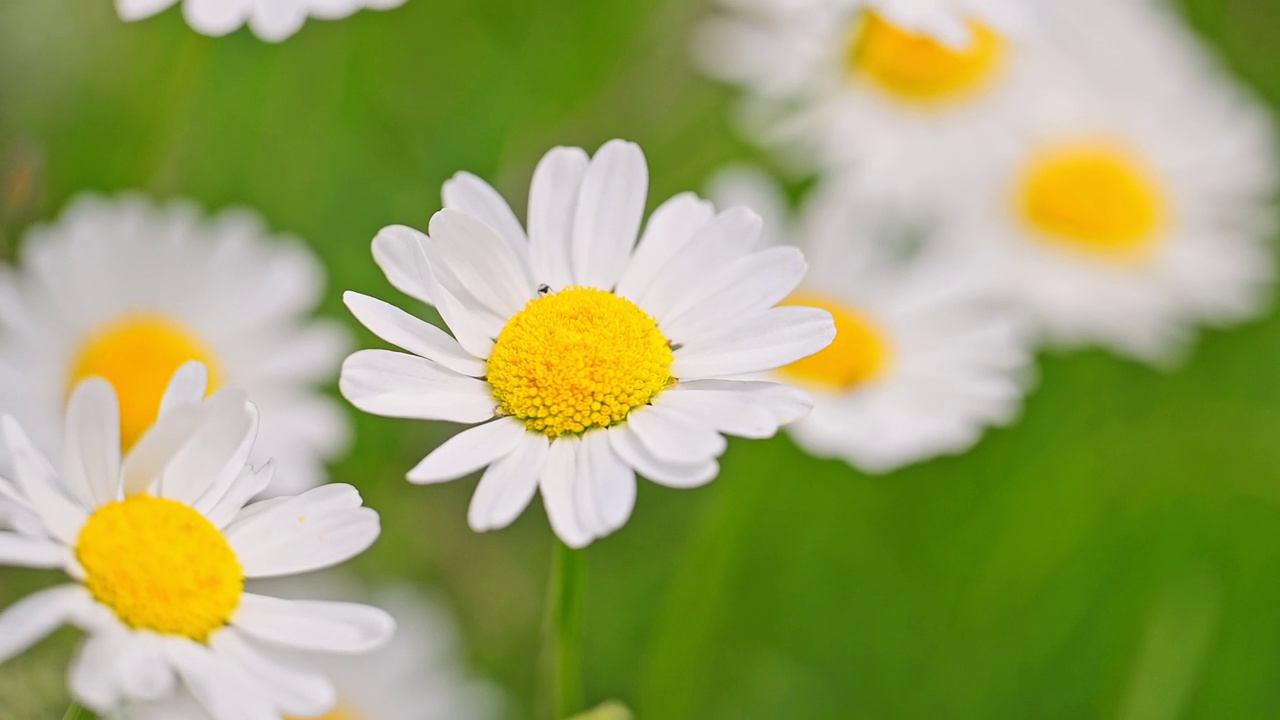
[658,380,813,438]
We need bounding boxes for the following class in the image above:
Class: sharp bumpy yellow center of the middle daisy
[488,287,673,438]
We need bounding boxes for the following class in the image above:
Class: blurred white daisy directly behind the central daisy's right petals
[712,169,1032,473]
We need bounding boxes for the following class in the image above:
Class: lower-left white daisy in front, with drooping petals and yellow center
[0,363,394,720]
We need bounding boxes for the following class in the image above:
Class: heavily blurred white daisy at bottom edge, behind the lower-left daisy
[120,575,500,720]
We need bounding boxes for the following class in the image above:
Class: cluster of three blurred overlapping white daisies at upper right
[692,0,1276,473]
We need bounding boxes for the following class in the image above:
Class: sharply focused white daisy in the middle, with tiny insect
[339,141,835,547]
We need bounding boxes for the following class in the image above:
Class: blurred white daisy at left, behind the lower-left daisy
[0,195,349,493]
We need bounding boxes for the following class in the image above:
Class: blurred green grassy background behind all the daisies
[0,0,1280,720]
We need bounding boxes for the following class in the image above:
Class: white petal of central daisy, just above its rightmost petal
[662,247,808,343]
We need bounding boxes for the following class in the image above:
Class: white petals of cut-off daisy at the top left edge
[115,0,404,42]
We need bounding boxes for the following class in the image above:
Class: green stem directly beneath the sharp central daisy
[545,539,586,720]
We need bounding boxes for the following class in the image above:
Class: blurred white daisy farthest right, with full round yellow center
[945,0,1276,363]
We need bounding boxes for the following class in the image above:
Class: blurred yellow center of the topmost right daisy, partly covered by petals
[847,12,1005,102]
